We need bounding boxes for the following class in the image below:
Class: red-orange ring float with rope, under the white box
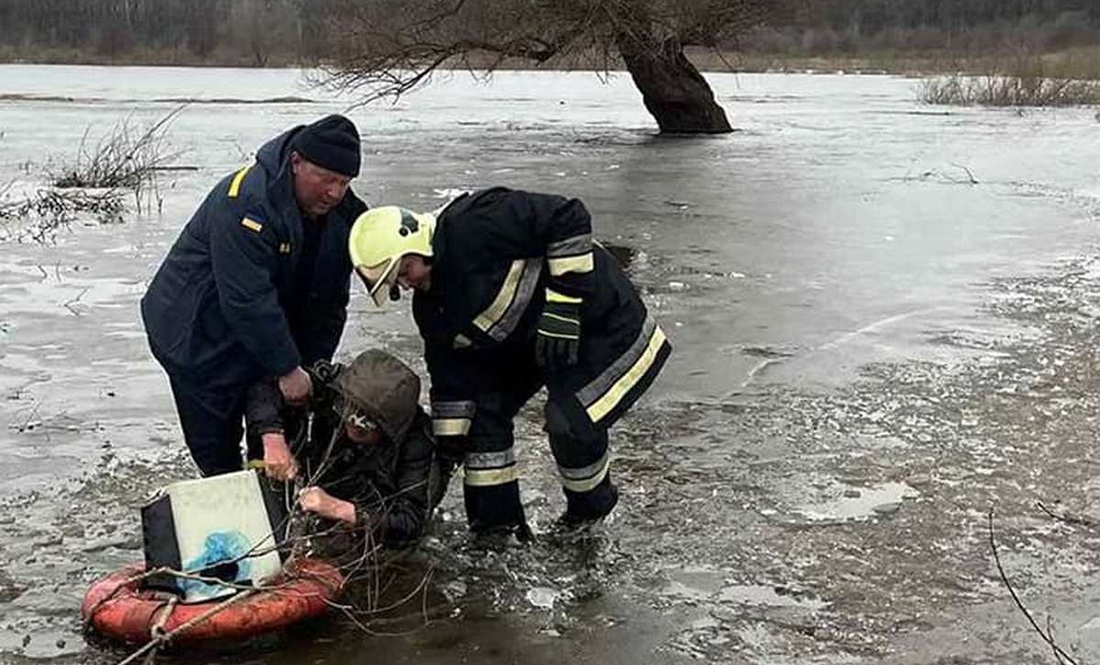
[80,558,343,644]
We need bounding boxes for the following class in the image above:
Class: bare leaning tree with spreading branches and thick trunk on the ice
[328,0,795,133]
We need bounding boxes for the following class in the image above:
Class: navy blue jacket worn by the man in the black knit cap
[141,125,366,413]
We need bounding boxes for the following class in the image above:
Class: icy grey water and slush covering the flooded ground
[0,61,1100,665]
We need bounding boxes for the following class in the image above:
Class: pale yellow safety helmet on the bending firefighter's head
[348,206,436,307]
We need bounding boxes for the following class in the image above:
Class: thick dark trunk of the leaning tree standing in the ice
[616,34,733,134]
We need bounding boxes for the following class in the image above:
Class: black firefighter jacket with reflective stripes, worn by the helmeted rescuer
[413,188,668,446]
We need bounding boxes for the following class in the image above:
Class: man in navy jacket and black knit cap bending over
[141,115,366,479]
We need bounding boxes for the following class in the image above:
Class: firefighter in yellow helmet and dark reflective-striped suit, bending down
[349,188,671,536]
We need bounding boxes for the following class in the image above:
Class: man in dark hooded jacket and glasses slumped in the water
[248,350,454,557]
